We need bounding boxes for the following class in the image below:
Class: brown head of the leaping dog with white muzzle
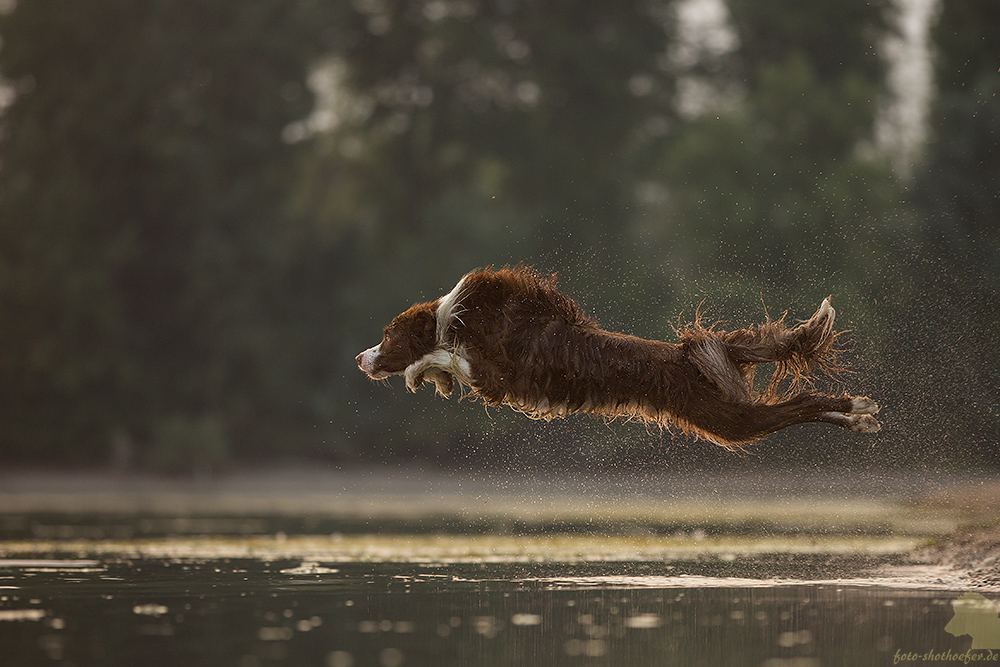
[355,302,437,380]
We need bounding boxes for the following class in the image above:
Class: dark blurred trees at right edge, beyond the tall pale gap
[892,0,1000,465]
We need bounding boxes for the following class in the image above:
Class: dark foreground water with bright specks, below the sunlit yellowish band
[0,553,984,667]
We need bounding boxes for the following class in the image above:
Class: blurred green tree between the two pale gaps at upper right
[640,0,902,303]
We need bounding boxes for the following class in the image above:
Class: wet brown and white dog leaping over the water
[356,265,880,448]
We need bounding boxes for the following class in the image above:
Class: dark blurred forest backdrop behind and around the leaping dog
[0,0,1000,472]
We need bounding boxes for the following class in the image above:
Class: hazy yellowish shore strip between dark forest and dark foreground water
[0,469,1000,590]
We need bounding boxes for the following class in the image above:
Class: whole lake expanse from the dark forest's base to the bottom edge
[0,475,984,667]
